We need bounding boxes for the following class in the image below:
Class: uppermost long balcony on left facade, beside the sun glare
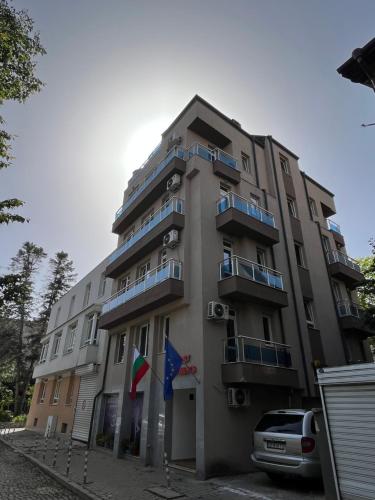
[112,147,186,234]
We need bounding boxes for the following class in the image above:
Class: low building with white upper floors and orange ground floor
[26,261,112,442]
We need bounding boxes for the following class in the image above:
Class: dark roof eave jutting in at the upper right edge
[337,38,375,92]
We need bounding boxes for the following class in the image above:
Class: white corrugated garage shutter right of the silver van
[323,384,375,500]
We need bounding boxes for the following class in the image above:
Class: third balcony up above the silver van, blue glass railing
[216,193,279,245]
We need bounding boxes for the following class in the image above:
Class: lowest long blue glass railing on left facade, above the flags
[103,259,182,314]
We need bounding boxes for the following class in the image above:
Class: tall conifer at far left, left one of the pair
[9,241,46,415]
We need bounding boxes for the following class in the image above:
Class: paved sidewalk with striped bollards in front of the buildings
[0,429,324,500]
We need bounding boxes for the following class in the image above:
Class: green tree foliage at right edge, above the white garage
[357,239,375,330]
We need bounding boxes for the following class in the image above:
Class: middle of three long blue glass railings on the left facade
[108,197,184,264]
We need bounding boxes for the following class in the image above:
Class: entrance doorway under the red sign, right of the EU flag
[171,389,196,470]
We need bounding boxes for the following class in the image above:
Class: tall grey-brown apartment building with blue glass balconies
[91,96,369,478]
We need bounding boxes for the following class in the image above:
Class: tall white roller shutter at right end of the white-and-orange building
[73,373,97,443]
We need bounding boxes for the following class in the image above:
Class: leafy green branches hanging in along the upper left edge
[0,0,46,224]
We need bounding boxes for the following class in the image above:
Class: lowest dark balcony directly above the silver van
[221,336,299,388]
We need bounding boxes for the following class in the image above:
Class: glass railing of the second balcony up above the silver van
[220,256,284,290]
